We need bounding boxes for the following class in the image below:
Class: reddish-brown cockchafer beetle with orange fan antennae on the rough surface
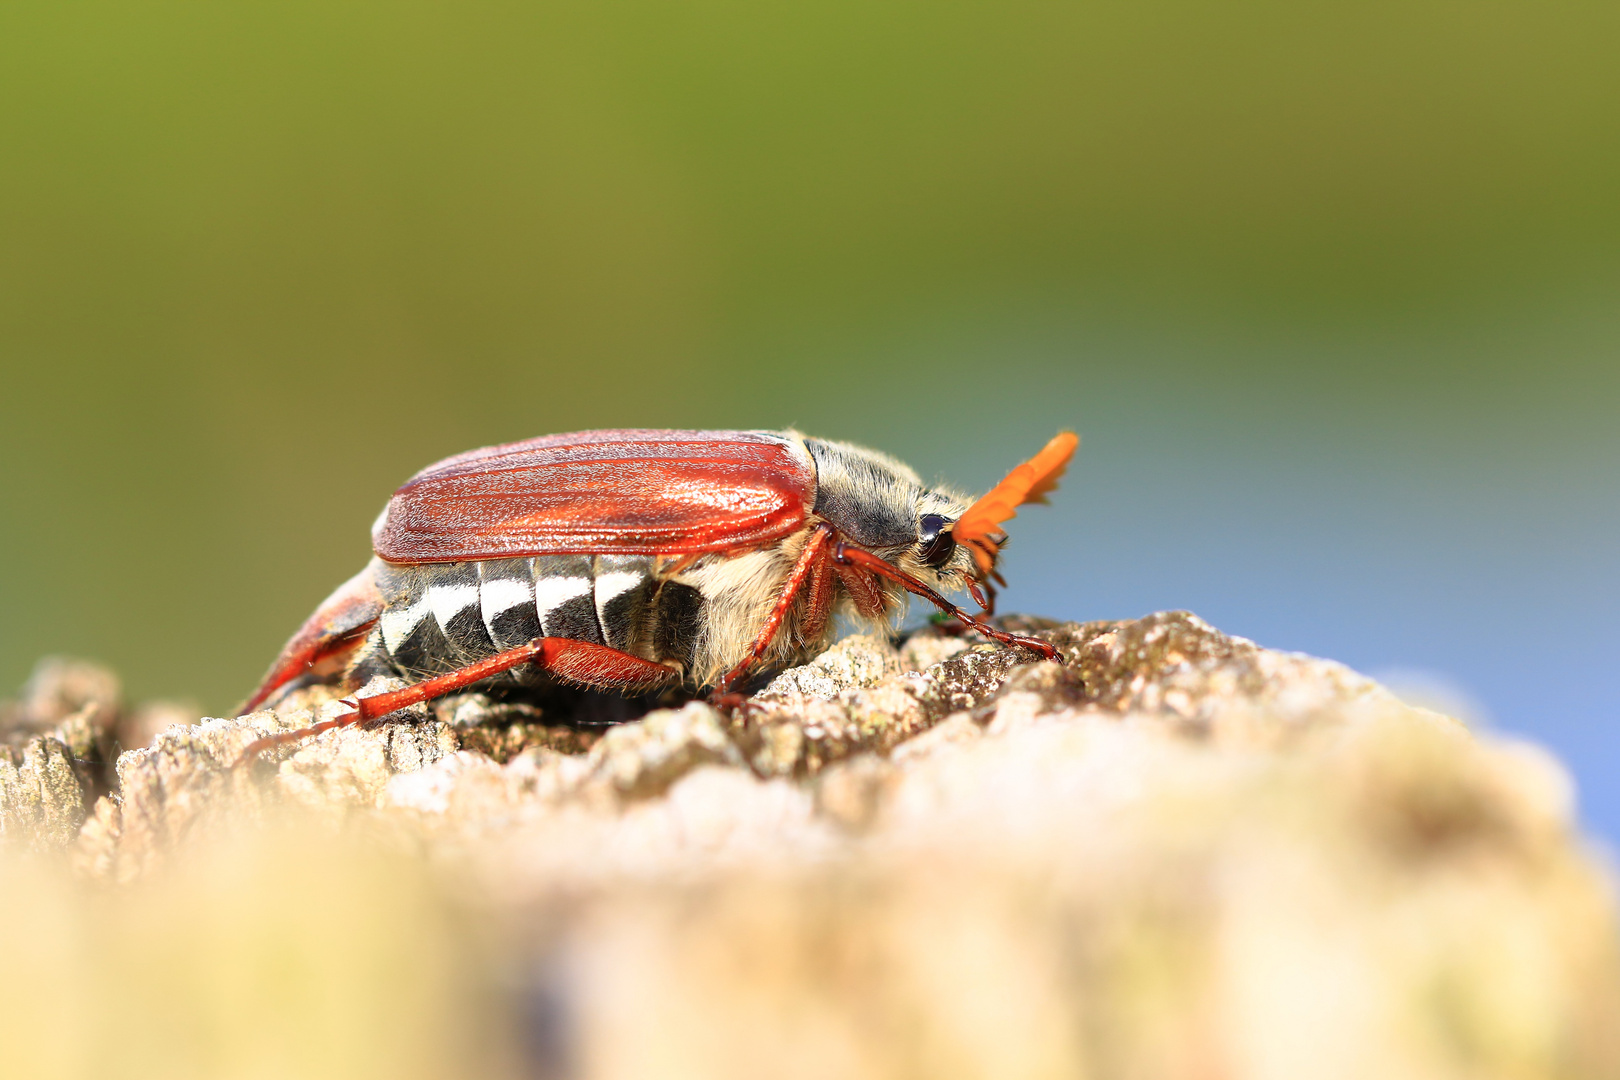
[243,431,1079,759]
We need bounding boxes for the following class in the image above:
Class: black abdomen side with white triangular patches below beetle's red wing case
[376,555,701,685]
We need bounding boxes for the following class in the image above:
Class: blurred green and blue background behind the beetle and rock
[0,0,1620,836]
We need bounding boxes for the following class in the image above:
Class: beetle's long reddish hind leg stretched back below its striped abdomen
[237,638,677,764]
